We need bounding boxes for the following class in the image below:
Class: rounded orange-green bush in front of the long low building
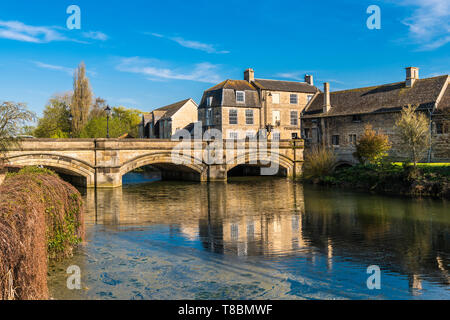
[354,124,391,164]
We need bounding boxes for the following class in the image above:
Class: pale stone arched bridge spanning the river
[6,139,303,188]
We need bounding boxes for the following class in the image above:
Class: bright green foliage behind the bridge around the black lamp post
[80,107,142,138]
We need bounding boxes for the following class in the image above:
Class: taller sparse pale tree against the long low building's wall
[395,105,430,168]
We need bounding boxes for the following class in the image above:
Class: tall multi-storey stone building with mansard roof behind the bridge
[198,69,319,139]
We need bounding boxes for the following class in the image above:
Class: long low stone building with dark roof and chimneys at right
[301,67,450,162]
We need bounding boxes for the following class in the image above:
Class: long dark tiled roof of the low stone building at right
[304,75,448,118]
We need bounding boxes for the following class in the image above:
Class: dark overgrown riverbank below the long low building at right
[304,163,450,199]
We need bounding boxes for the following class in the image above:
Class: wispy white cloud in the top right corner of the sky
[397,0,450,51]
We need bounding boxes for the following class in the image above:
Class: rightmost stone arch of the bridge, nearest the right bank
[227,151,294,177]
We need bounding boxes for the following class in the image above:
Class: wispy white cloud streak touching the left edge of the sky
[0,20,69,43]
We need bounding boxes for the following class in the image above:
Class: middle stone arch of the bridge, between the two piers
[119,152,207,181]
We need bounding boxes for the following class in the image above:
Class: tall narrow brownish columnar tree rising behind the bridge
[70,62,92,136]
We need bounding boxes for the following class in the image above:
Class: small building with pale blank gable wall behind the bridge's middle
[140,98,198,139]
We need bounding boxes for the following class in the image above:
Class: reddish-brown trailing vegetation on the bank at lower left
[0,167,84,300]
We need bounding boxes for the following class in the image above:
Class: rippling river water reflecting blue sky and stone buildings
[49,175,450,299]
